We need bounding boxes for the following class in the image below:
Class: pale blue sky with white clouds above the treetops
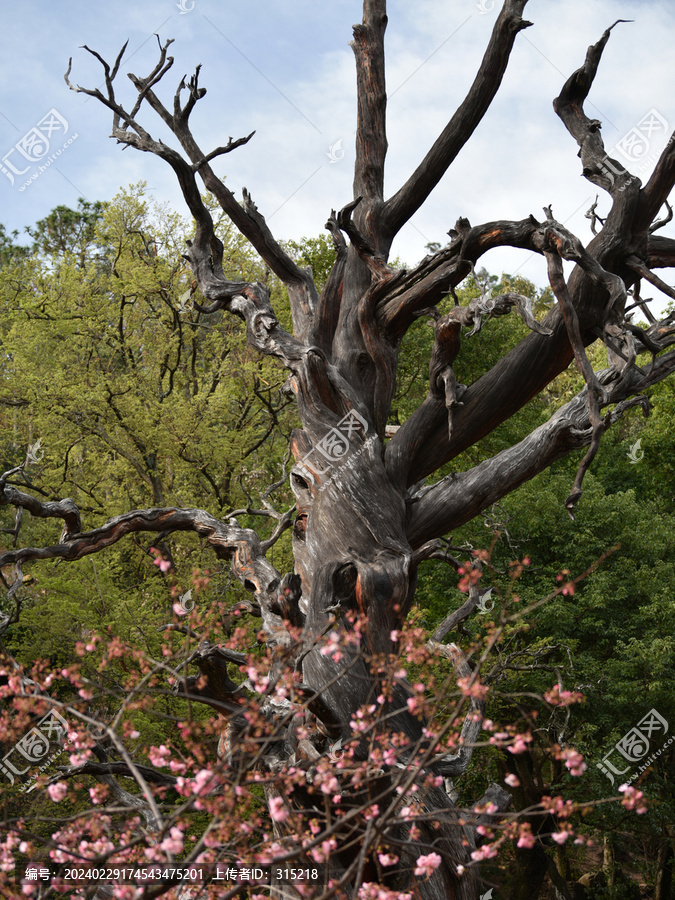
[0,0,675,310]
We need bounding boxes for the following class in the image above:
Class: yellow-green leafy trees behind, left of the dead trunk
[0,185,296,712]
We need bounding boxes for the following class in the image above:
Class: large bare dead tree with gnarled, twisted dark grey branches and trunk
[0,0,675,900]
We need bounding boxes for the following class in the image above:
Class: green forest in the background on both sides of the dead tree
[0,184,675,900]
